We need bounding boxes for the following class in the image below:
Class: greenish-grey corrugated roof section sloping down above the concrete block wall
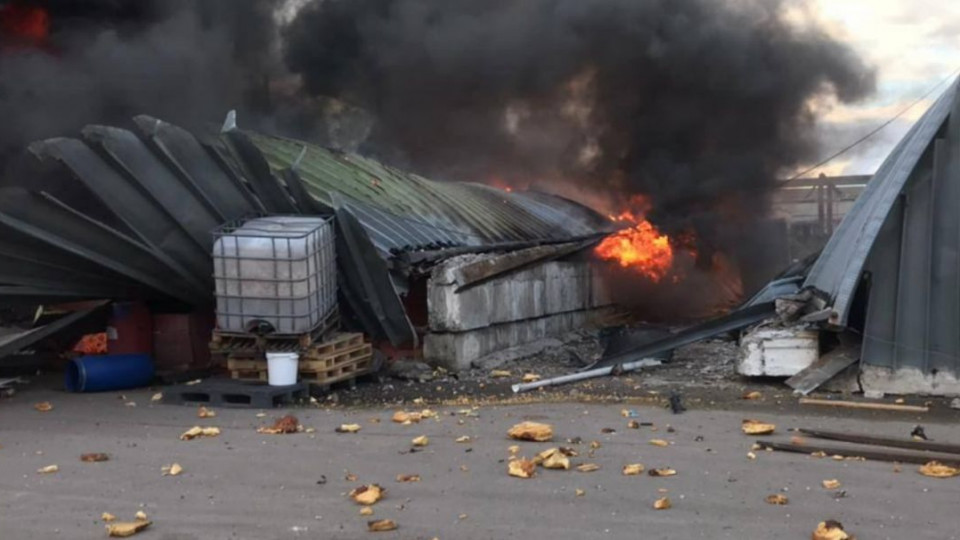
[247,133,610,253]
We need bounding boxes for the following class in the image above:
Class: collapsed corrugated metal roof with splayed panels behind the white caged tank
[0,116,610,344]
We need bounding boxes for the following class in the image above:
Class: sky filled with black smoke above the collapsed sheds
[0,0,960,226]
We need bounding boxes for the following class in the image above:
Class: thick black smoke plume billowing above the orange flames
[283,0,874,245]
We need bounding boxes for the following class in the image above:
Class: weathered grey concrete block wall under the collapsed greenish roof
[423,255,612,370]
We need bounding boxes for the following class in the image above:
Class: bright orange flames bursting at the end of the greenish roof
[594,211,673,283]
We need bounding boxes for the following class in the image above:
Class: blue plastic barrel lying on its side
[64,354,154,392]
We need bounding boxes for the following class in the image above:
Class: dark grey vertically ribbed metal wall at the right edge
[862,81,960,375]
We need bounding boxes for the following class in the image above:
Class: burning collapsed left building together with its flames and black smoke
[0,0,873,367]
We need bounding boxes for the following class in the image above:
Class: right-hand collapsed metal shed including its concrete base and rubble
[740,79,960,395]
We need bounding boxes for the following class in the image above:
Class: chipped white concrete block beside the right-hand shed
[737,328,820,377]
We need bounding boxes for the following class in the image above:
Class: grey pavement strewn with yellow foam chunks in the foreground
[0,388,960,540]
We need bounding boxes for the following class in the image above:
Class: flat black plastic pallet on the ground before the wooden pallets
[163,379,310,409]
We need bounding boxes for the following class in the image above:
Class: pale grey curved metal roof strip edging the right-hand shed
[804,77,958,325]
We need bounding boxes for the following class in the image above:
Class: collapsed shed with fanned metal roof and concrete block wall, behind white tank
[0,113,611,368]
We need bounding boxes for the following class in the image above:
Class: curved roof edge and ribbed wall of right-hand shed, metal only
[804,79,960,373]
